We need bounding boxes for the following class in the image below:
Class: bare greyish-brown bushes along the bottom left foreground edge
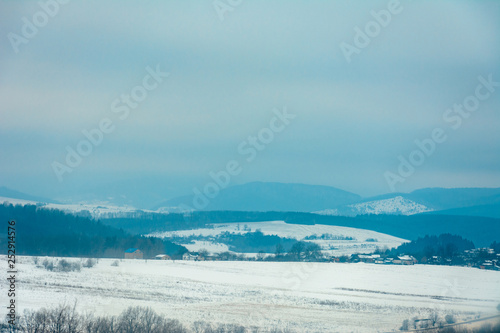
[0,305,291,333]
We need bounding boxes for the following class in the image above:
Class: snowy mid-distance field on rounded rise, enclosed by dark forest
[148,221,407,256]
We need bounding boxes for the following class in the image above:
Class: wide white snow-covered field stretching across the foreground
[0,256,500,332]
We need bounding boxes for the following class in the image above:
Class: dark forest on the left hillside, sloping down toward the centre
[0,204,187,258]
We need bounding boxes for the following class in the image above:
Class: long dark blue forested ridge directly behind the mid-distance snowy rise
[102,211,500,247]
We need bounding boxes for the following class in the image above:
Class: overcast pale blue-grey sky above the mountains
[0,0,500,199]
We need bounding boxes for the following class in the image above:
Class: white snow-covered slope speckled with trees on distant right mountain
[315,196,432,216]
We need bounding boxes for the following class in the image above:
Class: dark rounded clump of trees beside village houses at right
[390,234,475,261]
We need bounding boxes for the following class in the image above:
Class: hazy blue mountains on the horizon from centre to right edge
[158,182,500,217]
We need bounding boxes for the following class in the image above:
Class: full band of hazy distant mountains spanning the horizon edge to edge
[0,182,500,218]
